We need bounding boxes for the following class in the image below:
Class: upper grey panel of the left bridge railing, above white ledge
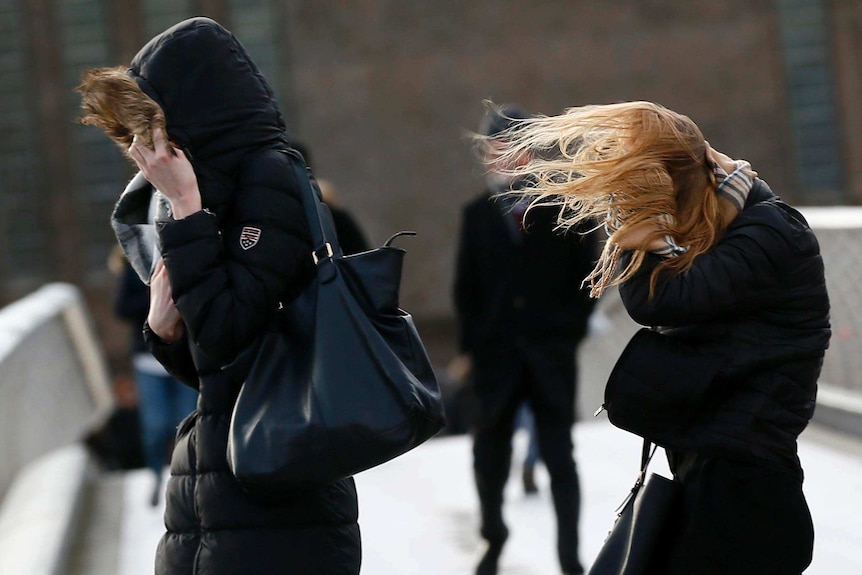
[0,284,113,499]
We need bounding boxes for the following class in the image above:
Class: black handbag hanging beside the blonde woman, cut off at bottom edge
[587,440,682,575]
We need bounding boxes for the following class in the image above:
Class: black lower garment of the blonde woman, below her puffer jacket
[657,454,814,575]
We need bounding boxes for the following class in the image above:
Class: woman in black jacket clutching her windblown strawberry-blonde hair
[498,102,830,575]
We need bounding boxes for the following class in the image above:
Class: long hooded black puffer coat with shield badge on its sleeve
[134,18,360,575]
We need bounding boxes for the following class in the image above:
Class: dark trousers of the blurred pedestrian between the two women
[473,366,582,573]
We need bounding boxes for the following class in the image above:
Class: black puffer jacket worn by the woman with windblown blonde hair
[620,180,830,477]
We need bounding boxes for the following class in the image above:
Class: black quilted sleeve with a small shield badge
[159,151,313,365]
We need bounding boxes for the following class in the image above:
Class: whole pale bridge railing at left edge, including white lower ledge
[0,284,113,575]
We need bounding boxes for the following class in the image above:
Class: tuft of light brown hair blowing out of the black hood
[76,66,165,160]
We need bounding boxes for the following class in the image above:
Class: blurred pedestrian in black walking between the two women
[454,106,596,575]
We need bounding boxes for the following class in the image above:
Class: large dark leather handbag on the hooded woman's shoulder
[227,150,445,496]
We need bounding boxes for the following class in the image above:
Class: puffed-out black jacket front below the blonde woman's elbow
[596,328,725,440]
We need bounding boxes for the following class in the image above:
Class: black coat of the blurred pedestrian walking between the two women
[454,193,597,419]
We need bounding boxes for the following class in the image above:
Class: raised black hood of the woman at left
[128,18,287,172]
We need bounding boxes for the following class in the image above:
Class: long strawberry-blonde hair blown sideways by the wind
[490,102,728,297]
